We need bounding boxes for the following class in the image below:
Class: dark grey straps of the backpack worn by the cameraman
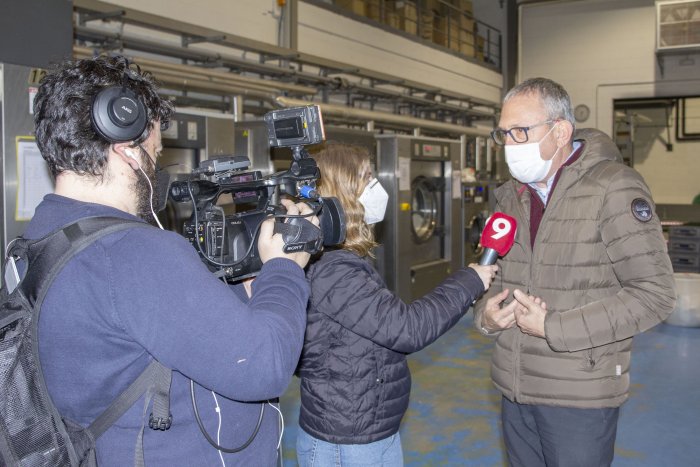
[19,217,172,465]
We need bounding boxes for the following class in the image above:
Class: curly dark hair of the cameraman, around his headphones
[34,56,174,178]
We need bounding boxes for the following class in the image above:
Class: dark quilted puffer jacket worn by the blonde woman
[298,250,484,444]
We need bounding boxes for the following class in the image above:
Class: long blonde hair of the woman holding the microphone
[312,143,377,257]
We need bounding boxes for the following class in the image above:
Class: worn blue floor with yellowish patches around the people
[281,313,700,467]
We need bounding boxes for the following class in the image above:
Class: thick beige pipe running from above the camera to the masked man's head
[275,96,489,136]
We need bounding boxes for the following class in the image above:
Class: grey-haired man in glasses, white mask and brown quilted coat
[475,78,676,467]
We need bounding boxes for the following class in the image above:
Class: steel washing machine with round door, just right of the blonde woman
[376,135,463,302]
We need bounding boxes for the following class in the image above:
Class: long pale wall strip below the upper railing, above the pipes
[110,0,503,104]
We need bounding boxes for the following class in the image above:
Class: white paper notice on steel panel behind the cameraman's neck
[15,136,54,221]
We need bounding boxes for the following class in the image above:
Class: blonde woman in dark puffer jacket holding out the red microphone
[297,144,497,467]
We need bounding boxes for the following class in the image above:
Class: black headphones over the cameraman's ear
[90,73,148,143]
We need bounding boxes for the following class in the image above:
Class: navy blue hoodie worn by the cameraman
[25,194,309,467]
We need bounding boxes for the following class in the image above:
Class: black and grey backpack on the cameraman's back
[0,217,172,467]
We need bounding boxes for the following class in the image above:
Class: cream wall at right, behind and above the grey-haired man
[518,0,700,204]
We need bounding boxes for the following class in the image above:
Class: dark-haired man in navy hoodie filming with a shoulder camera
[25,57,318,467]
